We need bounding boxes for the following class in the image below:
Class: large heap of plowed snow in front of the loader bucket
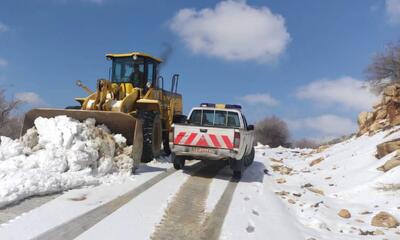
[0,116,133,207]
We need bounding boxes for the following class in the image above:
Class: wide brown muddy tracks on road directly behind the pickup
[151,162,237,240]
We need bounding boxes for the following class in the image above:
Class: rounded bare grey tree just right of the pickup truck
[255,116,290,147]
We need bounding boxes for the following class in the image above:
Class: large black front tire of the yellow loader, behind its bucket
[139,111,162,163]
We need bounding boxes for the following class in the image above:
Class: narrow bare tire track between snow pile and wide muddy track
[33,162,201,240]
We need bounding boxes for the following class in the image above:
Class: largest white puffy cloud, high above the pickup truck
[170,0,290,62]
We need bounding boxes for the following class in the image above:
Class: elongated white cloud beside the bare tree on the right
[296,77,378,111]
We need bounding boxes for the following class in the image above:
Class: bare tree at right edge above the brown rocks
[365,42,400,92]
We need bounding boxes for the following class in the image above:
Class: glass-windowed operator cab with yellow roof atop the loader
[107,52,161,89]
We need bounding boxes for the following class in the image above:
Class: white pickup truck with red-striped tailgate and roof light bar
[171,103,254,177]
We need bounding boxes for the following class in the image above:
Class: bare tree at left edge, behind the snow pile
[0,89,22,138]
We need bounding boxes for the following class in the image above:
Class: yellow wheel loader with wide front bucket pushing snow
[21,52,183,165]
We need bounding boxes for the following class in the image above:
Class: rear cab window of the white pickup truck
[189,109,240,128]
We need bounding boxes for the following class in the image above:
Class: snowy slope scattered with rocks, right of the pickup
[257,128,400,240]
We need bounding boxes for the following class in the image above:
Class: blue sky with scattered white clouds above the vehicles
[0,0,400,139]
